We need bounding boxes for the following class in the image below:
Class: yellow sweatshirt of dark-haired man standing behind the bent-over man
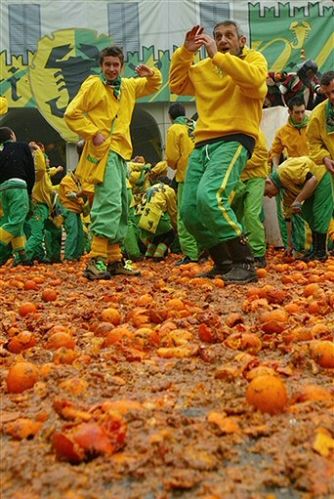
[270,123,309,158]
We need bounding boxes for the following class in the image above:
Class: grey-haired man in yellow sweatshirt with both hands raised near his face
[169,21,267,283]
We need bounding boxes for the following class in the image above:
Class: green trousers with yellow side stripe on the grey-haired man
[181,141,247,249]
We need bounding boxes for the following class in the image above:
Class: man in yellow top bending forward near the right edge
[265,156,334,261]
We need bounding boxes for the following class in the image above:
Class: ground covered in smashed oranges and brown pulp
[0,252,334,499]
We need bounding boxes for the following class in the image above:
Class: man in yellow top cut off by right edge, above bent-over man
[307,71,334,178]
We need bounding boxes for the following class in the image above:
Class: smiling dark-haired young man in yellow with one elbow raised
[65,47,162,280]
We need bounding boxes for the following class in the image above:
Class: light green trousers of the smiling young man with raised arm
[90,151,128,244]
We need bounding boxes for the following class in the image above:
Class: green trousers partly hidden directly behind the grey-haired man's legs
[232,178,266,257]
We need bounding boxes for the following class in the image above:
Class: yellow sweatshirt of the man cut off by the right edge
[307,99,334,165]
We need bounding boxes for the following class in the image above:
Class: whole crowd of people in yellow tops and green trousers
[0,20,334,284]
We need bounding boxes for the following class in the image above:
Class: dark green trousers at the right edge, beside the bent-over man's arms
[302,172,334,234]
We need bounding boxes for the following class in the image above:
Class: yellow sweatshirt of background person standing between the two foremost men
[166,123,194,182]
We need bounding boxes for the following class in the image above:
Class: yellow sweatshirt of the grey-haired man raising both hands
[169,47,268,144]
